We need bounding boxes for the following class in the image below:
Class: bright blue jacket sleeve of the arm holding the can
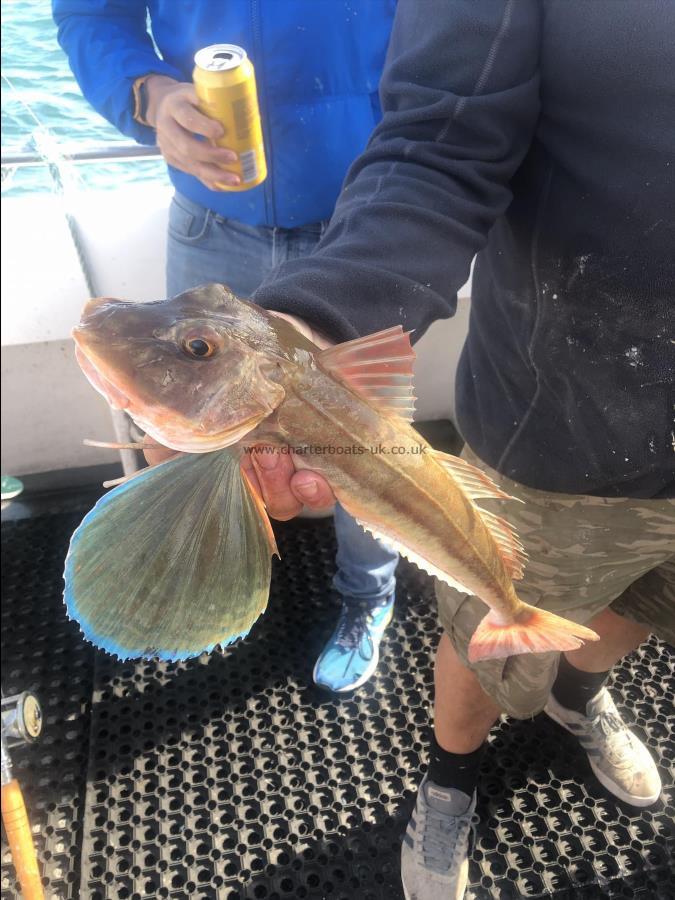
[52,0,185,144]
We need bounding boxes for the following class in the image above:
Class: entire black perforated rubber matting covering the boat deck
[2,502,675,900]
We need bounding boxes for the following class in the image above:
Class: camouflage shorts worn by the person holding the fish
[436,448,675,719]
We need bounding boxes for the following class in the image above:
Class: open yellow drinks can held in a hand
[192,44,267,191]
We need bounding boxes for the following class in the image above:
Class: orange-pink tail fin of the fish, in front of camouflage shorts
[468,603,599,662]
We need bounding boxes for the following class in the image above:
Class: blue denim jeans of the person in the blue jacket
[166,194,398,602]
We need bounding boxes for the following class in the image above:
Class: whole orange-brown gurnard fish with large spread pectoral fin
[65,284,597,661]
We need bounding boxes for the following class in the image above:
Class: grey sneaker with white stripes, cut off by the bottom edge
[401,775,476,900]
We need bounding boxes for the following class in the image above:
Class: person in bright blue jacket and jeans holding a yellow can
[52,0,398,691]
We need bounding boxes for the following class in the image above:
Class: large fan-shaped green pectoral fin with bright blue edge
[64,449,276,660]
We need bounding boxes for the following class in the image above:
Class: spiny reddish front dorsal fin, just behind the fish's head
[317,325,415,422]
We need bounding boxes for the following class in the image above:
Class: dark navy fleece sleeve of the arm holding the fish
[254,0,540,340]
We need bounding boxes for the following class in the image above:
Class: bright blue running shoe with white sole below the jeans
[314,594,394,694]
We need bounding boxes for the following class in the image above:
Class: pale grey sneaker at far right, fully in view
[544,688,661,806]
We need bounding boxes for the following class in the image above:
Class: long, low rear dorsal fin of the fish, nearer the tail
[434,451,527,581]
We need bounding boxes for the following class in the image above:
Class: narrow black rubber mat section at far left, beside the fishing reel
[2,514,95,900]
